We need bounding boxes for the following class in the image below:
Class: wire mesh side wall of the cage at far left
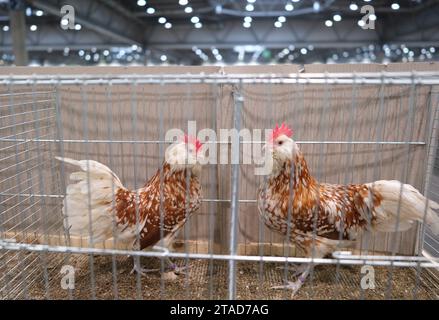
[0,82,62,298]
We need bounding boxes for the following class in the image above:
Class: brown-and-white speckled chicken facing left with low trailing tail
[258,124,439,296]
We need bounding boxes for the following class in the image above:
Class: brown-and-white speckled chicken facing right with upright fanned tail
[57,136,203,274]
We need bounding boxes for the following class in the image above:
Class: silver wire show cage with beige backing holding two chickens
[0,68,439,299]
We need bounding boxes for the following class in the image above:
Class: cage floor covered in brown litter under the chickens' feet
[3,253,439,299]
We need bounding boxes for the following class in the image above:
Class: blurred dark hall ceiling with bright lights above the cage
[0,0,439,66]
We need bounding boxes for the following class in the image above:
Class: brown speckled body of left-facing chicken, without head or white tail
[258,154,380,255]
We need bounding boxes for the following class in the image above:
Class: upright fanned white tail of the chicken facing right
[56,157,124,241]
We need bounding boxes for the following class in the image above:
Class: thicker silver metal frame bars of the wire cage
[0,67,439,299]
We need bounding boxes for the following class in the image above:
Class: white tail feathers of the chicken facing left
[368,180,439,234]
